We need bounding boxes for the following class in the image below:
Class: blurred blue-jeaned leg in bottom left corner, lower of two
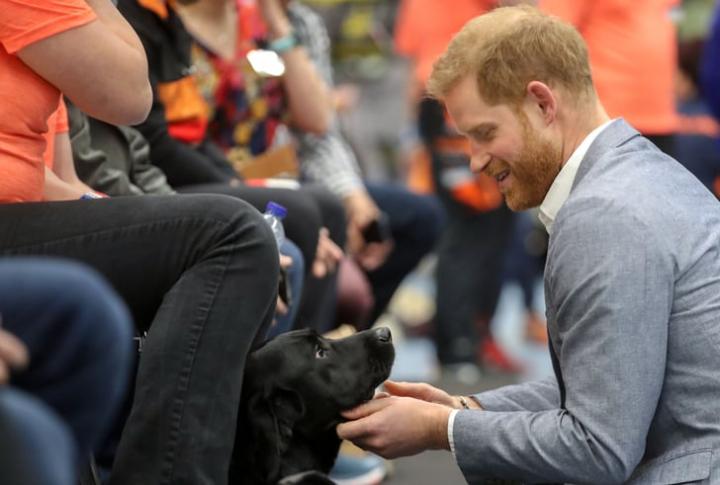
[0,387,77,485]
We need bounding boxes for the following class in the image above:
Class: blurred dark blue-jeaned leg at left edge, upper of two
[0,259,132,460]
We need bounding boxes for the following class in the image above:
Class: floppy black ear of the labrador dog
[249,388,305,480]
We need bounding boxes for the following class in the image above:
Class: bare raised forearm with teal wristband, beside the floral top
[258,0,333,134]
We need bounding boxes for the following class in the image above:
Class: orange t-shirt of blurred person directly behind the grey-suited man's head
[538,0,679,135]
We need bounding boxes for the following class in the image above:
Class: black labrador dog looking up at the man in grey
[230,328,395,485]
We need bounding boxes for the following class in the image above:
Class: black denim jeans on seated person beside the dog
[0,195,278,485]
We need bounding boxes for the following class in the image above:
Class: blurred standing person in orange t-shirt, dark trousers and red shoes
[395,0,524,378]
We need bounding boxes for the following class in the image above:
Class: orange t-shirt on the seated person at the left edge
[0,0,95,203]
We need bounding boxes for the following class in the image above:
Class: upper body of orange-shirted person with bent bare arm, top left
[0,0,151,203]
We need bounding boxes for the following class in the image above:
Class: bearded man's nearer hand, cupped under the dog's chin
[336,396,452,458]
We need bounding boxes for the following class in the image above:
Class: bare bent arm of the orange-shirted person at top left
[17,0,152,124]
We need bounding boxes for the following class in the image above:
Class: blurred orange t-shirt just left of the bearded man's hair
[395,0,497,85]
